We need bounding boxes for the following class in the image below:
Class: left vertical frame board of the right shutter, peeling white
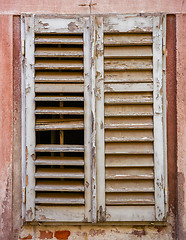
[95,17,105,222]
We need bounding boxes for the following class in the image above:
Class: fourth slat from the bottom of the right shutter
[105,154,154,167]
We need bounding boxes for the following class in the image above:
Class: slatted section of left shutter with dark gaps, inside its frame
[35,33,85,207]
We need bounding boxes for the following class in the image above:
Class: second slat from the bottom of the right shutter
[106,180,154,192]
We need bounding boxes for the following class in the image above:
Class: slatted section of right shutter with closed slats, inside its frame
[104,33,155,208]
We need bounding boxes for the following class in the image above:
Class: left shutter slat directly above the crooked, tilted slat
[35,107,84,115]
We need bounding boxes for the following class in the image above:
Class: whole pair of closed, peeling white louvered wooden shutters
[22,15,166,223]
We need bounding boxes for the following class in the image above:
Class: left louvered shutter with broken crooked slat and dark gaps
[23,15,91,222]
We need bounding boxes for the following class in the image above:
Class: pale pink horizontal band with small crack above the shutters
[0,0,186,14]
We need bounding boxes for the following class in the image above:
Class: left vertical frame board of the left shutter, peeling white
[24,15,35,221]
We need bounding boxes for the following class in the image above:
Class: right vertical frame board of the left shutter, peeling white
[83,17,92,222]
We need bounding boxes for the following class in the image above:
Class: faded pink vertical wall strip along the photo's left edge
[0,15,13,240]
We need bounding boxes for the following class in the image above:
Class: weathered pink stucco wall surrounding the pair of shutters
[0,0,186,240]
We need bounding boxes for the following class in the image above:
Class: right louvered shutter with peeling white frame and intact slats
[96,15,165,222]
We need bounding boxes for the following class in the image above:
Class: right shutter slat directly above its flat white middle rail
[104,70,152,83]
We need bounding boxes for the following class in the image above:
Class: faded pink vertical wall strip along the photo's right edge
[176,14,186,239]
